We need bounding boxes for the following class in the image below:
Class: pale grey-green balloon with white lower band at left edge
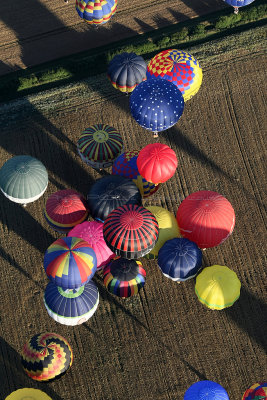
[0,156,48,204]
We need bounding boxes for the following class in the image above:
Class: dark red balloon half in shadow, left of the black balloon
[44,189,89,233]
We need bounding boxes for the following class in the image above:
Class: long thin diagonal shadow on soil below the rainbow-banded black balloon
[93,275,207,380]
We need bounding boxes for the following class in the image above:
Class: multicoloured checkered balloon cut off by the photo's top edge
[76,0,117,25]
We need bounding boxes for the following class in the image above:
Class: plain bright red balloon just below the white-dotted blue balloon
[137,143,178,184]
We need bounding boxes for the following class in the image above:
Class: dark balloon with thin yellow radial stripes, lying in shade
[77,124,123,169]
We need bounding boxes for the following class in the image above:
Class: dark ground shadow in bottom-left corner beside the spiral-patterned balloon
[0,337,63,400]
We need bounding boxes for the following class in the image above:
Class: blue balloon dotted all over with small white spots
[130,78,184,137]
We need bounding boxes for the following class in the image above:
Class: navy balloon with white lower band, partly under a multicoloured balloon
[44,281,99,326]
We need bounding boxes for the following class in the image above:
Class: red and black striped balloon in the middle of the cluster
[103,204,159,259]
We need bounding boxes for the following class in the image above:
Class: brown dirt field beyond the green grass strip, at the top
[0,0,226,75]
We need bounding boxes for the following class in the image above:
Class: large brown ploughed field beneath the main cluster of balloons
[0,30,267,400]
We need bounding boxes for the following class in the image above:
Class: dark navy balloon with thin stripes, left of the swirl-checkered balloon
[108,52,146,93]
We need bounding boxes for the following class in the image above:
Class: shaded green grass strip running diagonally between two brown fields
[0,0,267,102]
